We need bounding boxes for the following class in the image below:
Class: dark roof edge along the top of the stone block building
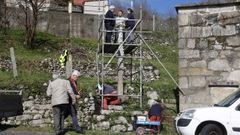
[175,1,240,12]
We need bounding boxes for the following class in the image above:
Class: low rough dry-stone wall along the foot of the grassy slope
[0,91,176,132]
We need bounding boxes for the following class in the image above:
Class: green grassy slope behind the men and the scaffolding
[0,30,177,98]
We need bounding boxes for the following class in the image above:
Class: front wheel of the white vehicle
[200,124,224,135]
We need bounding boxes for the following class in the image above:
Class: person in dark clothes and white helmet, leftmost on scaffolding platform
[104,5,116,43]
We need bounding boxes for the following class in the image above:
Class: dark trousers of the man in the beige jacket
[53,104,68,135]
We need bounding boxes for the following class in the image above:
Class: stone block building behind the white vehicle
[176,2,240,110]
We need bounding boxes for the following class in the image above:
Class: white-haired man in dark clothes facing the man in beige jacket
[68,70,83,133]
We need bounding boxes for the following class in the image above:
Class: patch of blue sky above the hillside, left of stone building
[110,0,201,14]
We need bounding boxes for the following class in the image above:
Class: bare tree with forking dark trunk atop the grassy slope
[18,0,47,49]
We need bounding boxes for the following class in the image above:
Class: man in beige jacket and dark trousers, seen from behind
[47,72,76,135]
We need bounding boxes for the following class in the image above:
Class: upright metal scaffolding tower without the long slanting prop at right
[96,0,143,108]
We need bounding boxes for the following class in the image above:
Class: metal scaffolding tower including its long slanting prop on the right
[96,0,185,108]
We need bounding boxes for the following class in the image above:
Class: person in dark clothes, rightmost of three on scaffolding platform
[125,8,135,43]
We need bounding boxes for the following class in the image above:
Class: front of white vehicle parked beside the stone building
[175,91,240,135]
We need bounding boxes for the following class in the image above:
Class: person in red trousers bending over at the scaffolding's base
[98,84,121,110]
